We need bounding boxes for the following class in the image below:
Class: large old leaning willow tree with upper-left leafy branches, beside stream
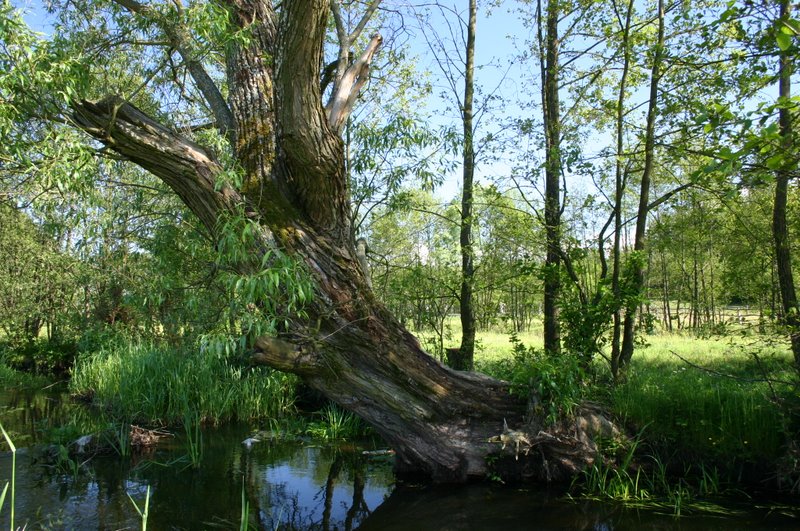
[5,0,612,481]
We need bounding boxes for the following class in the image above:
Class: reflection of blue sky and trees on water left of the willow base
[0,429,393,530]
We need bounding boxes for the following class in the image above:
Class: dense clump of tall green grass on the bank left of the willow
[70,343,296,424]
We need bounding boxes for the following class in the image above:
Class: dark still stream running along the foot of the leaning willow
[0,391,800,531]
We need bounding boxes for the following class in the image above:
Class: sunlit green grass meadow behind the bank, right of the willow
[434,323,800,482]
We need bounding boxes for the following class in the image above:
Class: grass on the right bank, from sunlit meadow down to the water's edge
[476,332,800,490]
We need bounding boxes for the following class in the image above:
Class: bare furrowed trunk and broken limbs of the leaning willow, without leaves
[74,0,616,481]
